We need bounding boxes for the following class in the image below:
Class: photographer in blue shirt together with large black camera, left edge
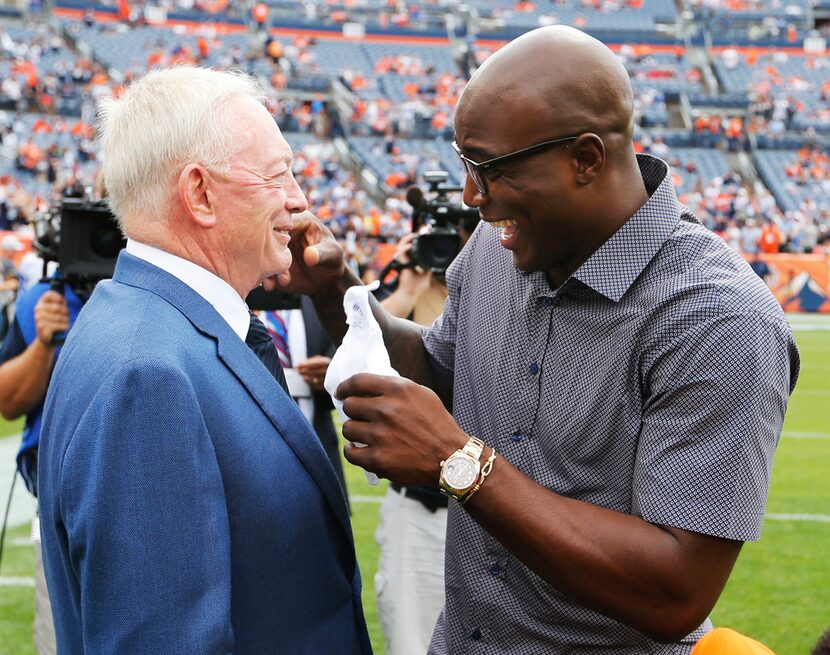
[0,181,122,655]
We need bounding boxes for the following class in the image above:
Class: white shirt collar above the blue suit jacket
[127,239,251,341]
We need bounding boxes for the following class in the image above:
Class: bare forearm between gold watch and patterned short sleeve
[465,459,741,641]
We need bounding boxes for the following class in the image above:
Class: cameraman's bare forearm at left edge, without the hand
[0,340,55,420]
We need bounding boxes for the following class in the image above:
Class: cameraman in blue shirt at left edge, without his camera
[0,282,85,655]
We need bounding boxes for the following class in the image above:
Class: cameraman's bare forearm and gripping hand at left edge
[0,291,69,420]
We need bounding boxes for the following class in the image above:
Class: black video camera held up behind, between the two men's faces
[406,171,479,274]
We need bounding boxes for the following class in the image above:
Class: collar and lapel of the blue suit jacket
[113,252,352,543]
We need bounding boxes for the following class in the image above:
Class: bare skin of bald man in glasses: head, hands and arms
[281,27,742,642]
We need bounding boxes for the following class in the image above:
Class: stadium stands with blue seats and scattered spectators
[0,0,830,266]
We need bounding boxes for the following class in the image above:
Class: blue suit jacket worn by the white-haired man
[39,253,371,655]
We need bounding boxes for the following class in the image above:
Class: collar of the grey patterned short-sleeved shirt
[573,155,682,302]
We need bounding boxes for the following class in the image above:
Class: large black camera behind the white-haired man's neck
[34,197,126,293]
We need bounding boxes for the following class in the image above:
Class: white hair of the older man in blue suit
[98,66,265,230]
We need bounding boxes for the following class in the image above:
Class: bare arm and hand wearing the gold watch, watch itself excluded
[340,376,741,641]
